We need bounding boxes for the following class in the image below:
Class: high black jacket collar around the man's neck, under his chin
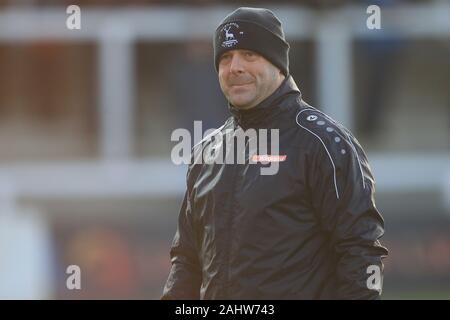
[228,75,301,129]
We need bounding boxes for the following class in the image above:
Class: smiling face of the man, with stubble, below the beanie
[219,49,284,109]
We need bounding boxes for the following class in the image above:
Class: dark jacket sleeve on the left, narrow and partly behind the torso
[161,176,201,300]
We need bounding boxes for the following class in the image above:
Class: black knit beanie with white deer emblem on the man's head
[214,7,289,76]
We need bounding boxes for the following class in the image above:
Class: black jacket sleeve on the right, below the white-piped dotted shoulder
[310,125,388,299]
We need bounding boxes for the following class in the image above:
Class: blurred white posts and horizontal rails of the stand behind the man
[0,2,450,200]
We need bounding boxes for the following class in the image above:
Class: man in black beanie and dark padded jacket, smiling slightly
[162,8,387,299]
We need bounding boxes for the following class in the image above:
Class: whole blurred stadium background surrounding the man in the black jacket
[0,0,450,299]
